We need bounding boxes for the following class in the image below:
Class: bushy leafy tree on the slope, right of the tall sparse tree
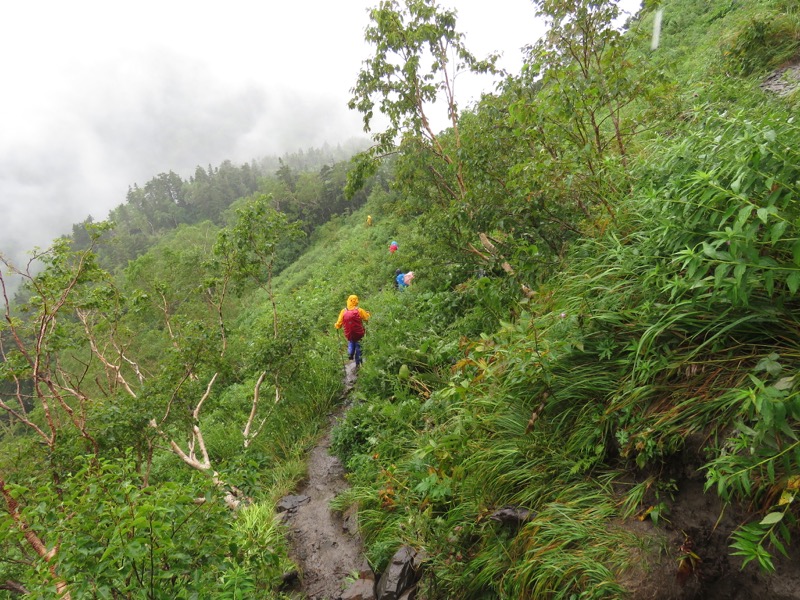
[506,0,673,222]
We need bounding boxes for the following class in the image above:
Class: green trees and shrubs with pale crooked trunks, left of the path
[0,210,335,598]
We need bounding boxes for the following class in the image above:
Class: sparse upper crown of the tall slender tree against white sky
[348,0,496,200]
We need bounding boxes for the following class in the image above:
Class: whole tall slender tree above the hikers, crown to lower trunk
[348,0,520,282]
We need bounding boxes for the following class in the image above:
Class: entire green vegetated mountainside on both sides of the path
[0,0,800,600]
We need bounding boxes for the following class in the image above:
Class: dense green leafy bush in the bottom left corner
[0,457,253,599]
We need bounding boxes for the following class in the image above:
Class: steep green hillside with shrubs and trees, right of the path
[324,1,800,598]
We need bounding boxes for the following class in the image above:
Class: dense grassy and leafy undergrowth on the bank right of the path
[326,102,800,598]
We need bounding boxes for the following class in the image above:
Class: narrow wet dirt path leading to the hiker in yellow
[279,363,371,600]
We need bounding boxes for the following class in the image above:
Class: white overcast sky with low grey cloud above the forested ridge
[0,0,638,263]
